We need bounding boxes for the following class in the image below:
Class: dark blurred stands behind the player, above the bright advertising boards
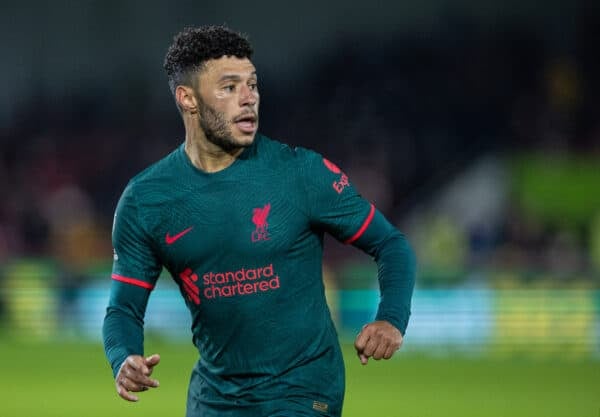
[0,0,600,334]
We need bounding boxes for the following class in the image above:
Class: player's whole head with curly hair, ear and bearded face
[164,26,259,150]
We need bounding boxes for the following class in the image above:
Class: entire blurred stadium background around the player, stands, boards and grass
[0,0,600,417]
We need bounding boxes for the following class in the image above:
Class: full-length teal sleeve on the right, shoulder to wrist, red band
[302,150,416,334]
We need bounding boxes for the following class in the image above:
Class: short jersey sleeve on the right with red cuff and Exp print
[297,148,375,243]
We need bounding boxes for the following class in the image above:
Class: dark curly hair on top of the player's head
[164,26,253,95]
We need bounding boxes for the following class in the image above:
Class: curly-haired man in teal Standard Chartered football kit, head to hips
[103,26,414,417]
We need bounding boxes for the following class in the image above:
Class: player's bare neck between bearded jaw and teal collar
[185,121,244,173]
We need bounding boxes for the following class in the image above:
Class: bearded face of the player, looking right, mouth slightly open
[195,57,259,151]
